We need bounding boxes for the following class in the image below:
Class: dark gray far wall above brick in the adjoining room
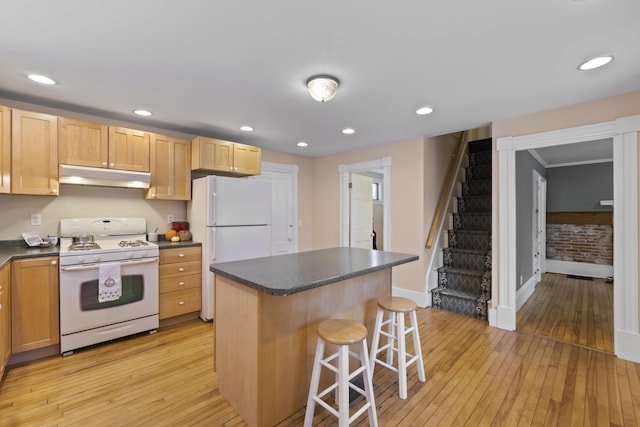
[547,162,613,212]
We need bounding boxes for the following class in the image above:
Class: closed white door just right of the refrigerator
[252,162,298,255]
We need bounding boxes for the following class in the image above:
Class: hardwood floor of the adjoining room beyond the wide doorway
[516,273,614,353]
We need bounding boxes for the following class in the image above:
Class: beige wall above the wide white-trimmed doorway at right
[493,92,640,320]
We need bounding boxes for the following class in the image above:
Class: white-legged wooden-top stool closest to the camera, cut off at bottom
[304,319,378,427]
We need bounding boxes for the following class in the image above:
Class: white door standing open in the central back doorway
[349,174,373,249]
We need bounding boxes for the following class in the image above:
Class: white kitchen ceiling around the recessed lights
[0,0,640,157]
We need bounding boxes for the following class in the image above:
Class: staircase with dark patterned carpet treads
[431,139,491,320]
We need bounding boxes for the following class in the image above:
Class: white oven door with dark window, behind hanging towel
[60,258,158,335]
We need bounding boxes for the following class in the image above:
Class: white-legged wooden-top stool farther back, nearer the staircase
[371,296,425,399]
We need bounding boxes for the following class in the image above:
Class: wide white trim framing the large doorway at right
[490,116,640,361]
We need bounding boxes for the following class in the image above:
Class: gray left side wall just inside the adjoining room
[516,151,548,289]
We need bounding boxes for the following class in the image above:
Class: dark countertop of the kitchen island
[209,247,418,296]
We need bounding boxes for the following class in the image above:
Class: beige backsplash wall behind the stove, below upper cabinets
[0,184,187,240]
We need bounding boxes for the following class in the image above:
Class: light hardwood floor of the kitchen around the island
[0,309,640,426]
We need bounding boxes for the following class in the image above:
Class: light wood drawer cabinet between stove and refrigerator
[160,246,202,320]
